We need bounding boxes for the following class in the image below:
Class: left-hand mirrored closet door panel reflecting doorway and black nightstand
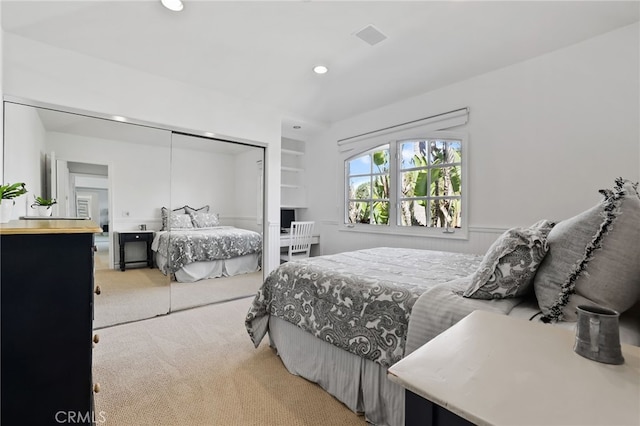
[4,102,171,328]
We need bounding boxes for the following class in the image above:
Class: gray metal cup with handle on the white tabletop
[573,305,624,364]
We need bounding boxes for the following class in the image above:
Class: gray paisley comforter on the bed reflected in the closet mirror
[153,226,262,274]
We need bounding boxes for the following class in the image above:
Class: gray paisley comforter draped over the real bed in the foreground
[245,247,482,367]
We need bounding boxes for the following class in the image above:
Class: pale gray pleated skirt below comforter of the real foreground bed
[269,317,404,426]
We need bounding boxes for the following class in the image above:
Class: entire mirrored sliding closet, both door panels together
[3,102,264,328]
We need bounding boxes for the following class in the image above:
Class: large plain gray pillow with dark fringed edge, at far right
[534,178,640,322]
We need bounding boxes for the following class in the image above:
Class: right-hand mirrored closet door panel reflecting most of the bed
[168,133,264,311]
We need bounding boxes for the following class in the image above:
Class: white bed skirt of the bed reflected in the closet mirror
[156,252,261,283]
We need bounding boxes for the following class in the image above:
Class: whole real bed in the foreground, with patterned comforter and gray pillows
[245,179,640,426]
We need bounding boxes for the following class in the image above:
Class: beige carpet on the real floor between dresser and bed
[93,298,366,426]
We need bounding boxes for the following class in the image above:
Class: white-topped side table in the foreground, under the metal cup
[388,311,640,426]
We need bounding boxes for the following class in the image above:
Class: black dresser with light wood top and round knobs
[0,220,101,426]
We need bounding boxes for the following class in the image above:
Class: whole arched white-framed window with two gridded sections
[344,134,466,238]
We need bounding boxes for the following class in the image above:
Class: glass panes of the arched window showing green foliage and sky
[347,140,462,228]
